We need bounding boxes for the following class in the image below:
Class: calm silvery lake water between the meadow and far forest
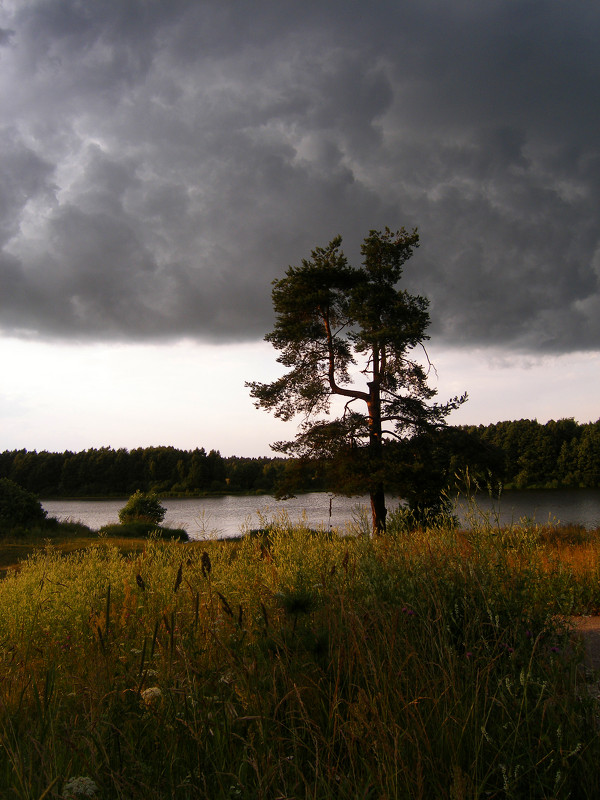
[42,489,600,539]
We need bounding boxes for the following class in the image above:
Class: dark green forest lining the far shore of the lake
[0,419,600,498]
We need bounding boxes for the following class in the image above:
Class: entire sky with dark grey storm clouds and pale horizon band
[0,0,600,455]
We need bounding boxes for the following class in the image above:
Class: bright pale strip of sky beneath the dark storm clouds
[0,338,600,457]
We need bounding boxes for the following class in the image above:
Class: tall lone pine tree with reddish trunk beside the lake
[246,228,466,535]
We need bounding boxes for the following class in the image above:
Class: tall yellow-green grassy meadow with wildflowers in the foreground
[0,515,600,800]
